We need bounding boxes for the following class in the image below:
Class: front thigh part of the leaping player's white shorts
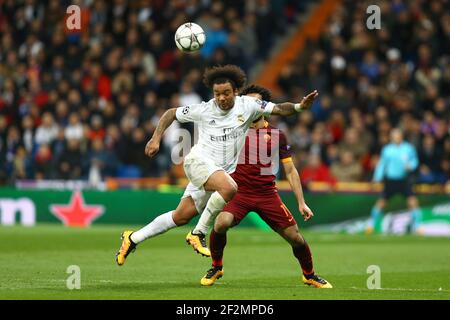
[183,146,223,189]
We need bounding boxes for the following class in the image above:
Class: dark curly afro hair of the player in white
[203,64,247,90]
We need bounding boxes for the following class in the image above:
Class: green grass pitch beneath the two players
[0,225,450,300]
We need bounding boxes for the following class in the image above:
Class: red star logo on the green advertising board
[50,191,105,227]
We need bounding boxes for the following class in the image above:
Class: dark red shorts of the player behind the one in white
[222,191,297,231]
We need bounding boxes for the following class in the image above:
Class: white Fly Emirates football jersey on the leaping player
[176,96,275,173]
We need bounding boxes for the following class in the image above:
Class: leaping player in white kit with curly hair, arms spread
[116,65,318,266]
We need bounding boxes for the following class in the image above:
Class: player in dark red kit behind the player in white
[201,85,332,288]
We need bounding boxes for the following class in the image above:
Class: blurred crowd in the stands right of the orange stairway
[278,0,450,183]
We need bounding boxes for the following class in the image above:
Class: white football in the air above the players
[175,22,206,52]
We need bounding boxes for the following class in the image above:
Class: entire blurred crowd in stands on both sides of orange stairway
[0,0,450,184]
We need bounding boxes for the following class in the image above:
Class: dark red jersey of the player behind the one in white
[231,122,292,195]
